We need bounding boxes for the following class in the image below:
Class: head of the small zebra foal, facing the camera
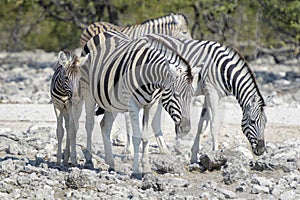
[58,51,88,103]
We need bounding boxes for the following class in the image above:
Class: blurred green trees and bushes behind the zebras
[0,0,300,63]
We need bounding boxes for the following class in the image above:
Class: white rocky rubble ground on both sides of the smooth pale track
[0,51,300,200]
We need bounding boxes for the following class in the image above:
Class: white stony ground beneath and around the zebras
[0,51,300,199]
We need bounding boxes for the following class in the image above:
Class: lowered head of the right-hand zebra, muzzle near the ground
[242,95,267,156]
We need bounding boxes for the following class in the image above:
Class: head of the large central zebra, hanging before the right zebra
[162,61,203,138]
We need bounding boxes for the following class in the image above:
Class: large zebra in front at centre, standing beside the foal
[81,32,201,178]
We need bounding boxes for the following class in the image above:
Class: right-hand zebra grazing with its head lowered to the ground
[125,34,267,163]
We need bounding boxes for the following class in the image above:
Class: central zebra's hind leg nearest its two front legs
[100,111,116,171]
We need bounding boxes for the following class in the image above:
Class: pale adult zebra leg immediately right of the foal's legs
[84,94,95,168]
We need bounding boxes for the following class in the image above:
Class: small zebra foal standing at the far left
[50,51,88,166]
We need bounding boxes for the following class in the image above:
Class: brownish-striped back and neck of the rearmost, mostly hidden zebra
[80,13,192,47]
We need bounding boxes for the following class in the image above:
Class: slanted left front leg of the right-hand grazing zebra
[191,96,209,163]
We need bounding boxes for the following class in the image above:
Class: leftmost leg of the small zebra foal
[54,106,64,166]
